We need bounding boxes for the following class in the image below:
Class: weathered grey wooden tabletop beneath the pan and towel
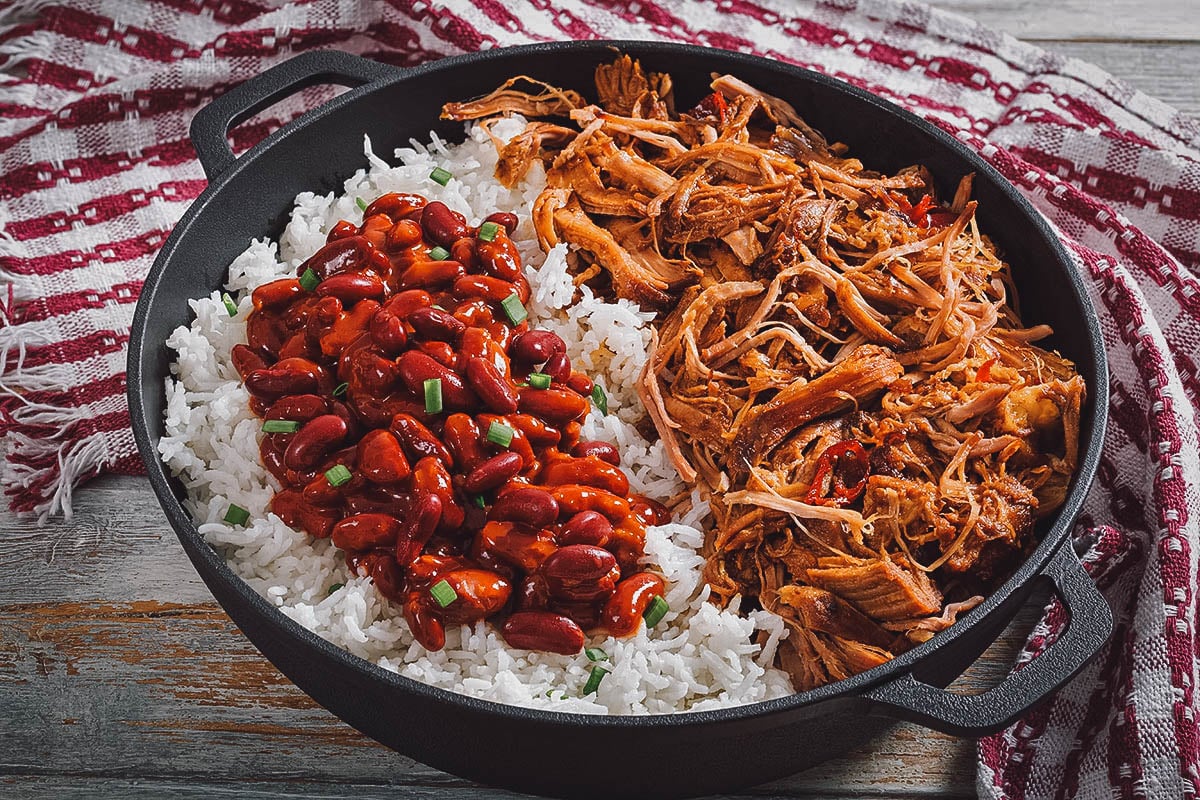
[0,0,1200,798]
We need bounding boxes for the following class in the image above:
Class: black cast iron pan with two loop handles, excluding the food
[128,42,1112,798]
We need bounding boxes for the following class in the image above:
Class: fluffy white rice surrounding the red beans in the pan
[158,119,793,714]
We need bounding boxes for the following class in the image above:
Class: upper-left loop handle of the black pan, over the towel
[191,50,400,181]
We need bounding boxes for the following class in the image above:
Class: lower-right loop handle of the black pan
[865,540,1114,738]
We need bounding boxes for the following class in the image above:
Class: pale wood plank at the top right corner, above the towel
[930,0,1200,42]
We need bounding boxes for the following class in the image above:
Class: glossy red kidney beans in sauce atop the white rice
[233,193,670,654]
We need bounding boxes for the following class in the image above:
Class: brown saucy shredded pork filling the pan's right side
[444,56,1085,688]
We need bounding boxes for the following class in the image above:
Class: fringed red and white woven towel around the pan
[0,0,1200,800]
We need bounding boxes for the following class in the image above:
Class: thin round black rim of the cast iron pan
[127,40,1108,730]
